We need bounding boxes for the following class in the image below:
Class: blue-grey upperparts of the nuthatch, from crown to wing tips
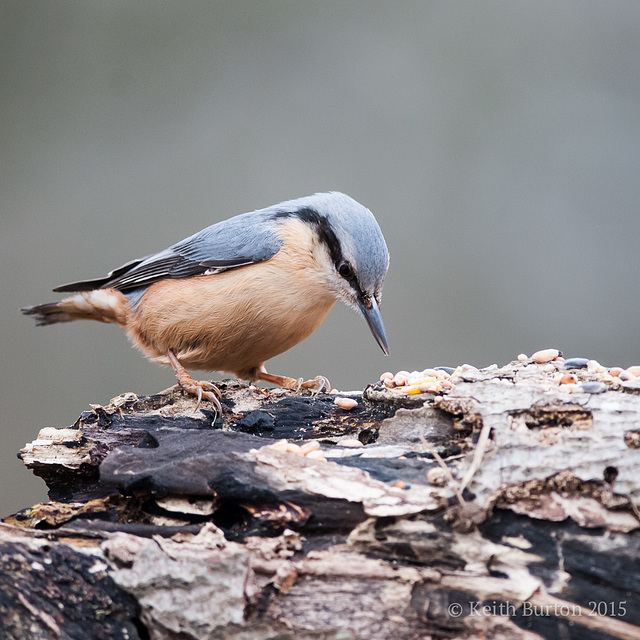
[54,192,389,297]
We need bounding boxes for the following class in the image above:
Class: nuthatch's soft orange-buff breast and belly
[127,220,336,379]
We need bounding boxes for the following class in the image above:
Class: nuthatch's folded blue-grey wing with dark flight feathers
[54,210,282,292]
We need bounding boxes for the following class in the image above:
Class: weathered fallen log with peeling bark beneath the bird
[0,359,640,640]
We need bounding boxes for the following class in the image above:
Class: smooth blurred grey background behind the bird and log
[0,0,640,515]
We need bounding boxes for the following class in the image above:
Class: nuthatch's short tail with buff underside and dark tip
[21,289,129,327]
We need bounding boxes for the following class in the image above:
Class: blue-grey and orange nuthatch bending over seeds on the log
[22,192,389,409]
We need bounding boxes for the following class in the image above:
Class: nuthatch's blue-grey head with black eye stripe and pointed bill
[272,191,389,355]
